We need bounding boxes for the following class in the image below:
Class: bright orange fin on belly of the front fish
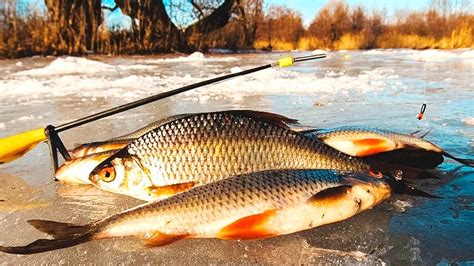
[217,210,276,240]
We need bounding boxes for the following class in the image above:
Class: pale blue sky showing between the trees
[17,0,440,27]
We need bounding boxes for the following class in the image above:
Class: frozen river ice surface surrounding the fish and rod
[0,50,474,265]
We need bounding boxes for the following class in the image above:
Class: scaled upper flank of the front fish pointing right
[104,170,343,231]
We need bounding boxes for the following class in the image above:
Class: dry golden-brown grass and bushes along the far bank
[0,2,474,58]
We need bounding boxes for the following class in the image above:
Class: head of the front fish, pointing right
[346,173,392,211]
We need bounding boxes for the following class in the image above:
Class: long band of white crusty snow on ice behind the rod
[0,53,398,99]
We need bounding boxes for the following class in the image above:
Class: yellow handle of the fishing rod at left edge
[0,128,47,164]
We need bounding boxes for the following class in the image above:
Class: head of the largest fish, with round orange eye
[89,150,153,200]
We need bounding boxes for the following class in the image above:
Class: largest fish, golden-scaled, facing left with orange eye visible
[89,110,430,201]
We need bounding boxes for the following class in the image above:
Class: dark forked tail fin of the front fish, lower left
[0,220,94,254]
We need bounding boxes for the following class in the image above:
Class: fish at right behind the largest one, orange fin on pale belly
[305,126,474,169]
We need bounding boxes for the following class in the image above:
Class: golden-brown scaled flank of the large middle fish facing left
[123,110,369,187]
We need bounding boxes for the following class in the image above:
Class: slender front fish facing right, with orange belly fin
[0,169,391,254]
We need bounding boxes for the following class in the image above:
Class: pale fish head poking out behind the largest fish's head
[54,150,118,185]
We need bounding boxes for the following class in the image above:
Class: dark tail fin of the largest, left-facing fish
[371,162,440,180]
